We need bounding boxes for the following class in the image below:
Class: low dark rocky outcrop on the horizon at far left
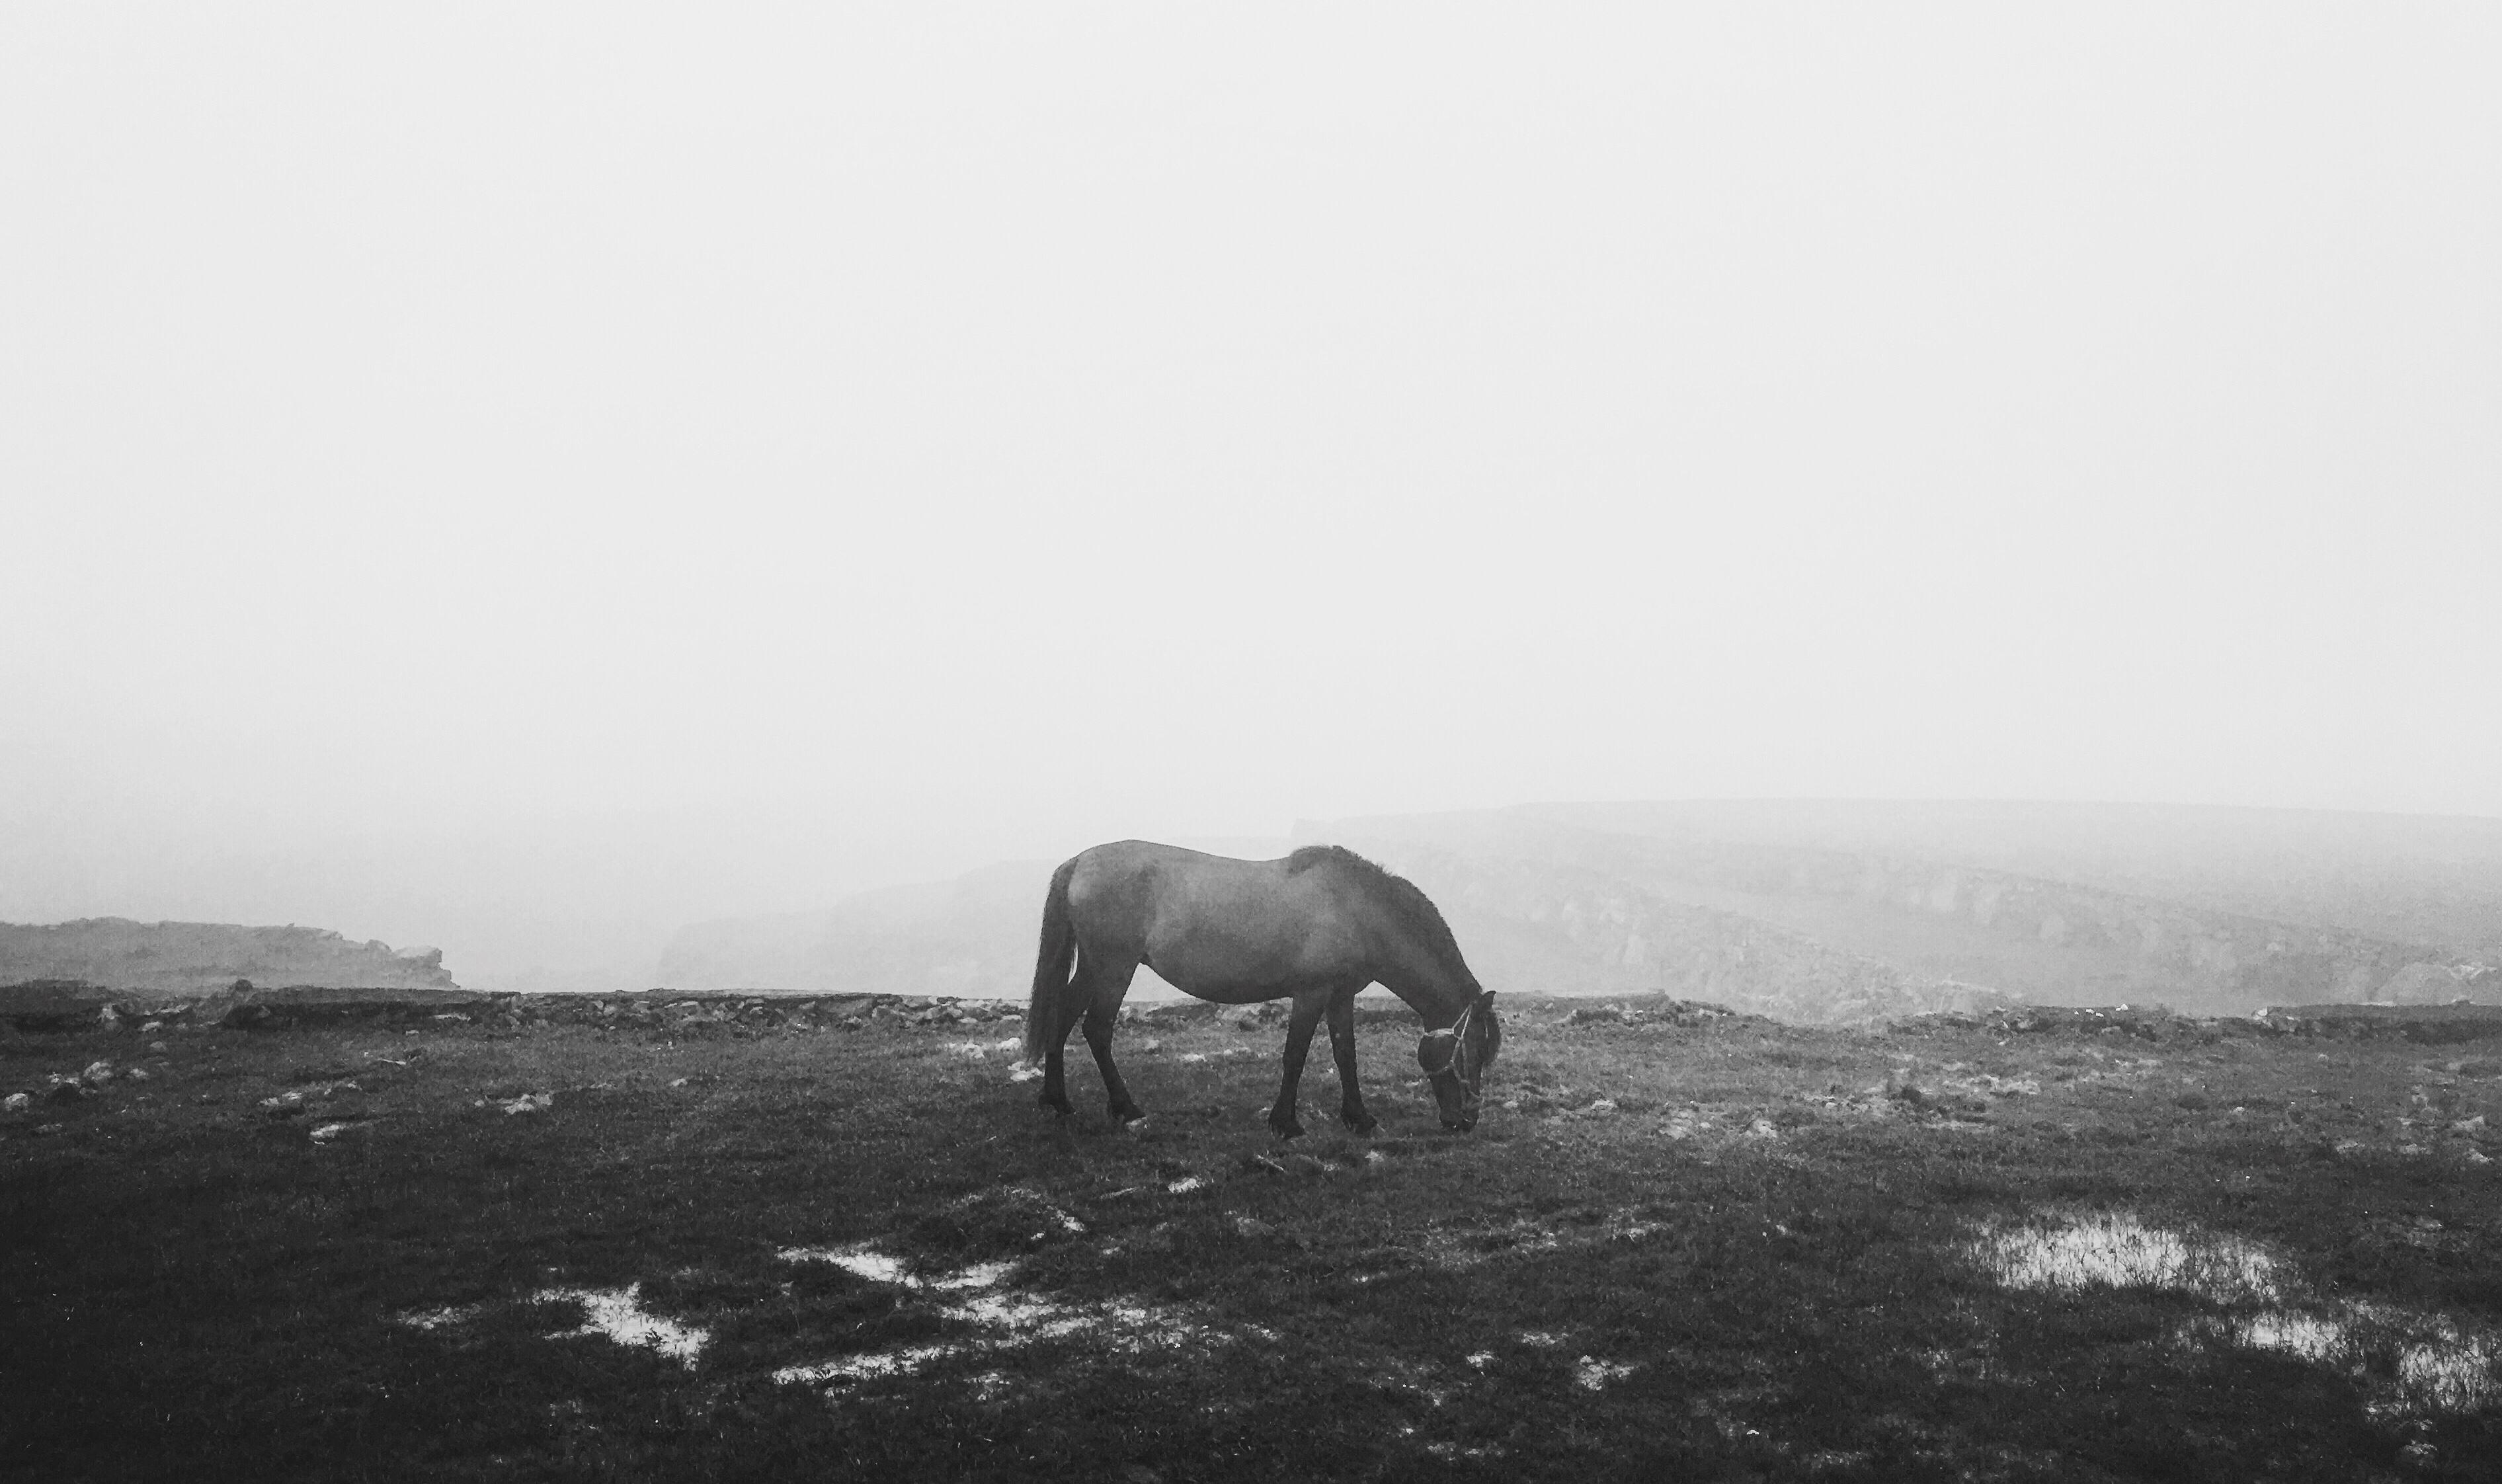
[0,918,460,999]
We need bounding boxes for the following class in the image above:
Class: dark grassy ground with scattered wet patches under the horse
[0,1003,2502,1481]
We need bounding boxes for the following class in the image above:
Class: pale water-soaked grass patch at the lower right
[1964,1211,2502,1419]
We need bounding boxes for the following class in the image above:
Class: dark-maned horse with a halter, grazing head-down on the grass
[1026,841,1504,1139]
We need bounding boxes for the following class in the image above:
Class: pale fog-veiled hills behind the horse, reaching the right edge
[661,801,2502,1023]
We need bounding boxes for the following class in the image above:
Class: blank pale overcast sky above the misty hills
[0,0,2502,974]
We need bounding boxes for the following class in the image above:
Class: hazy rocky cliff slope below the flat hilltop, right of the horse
[1299,806,2497,1019]
